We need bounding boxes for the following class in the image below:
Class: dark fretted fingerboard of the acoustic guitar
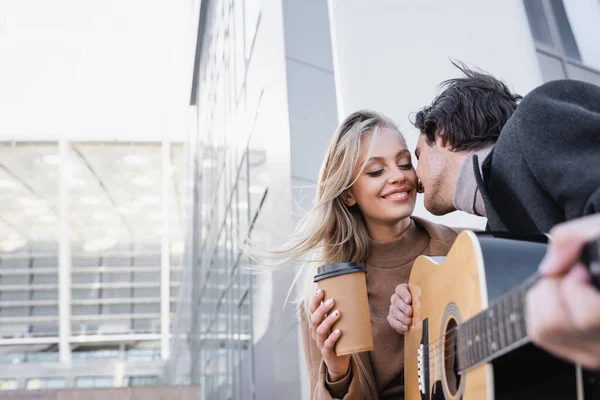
[458,277,538,372]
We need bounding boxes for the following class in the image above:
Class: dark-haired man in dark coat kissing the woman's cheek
[413,65,600,393]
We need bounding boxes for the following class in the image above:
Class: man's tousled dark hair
[412,61,522,151]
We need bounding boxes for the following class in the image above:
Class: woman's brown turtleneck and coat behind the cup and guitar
[301,217,457,400]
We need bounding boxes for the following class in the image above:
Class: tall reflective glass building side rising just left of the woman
[166,1,337,399]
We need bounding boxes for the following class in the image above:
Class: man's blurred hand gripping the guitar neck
[527,214,600,369]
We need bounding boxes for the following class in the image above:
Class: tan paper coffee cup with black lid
[314,262,373,356]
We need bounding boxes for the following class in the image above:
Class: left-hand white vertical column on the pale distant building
[58,137,71,363]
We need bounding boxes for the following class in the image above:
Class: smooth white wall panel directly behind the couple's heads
[329,0,542,228]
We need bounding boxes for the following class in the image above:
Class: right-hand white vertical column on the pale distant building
[160,139,171,360]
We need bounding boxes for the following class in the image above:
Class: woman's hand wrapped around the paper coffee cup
[310,289,350,382]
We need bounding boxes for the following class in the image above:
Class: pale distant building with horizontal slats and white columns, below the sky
[0,141,184,390]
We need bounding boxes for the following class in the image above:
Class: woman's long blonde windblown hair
[251,110,404,312]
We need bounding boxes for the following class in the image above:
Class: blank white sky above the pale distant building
[0,0,199,141]
